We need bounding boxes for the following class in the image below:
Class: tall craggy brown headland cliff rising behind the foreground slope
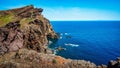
[0,5,57,54]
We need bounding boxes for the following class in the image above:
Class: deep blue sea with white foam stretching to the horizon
[49,21,120,65]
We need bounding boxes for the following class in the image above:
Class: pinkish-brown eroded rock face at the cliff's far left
[0,21,24,54]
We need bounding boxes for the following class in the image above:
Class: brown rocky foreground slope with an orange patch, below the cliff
[0,48,96,68]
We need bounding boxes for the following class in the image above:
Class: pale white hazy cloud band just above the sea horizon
[43,7,120,20]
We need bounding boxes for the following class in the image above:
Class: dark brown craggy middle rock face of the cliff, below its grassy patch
[23,19,57,53]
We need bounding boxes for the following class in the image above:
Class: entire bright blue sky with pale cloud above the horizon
[0,0,120,21]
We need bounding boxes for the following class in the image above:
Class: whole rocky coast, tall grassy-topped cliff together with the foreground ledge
[0,5,120,68]
